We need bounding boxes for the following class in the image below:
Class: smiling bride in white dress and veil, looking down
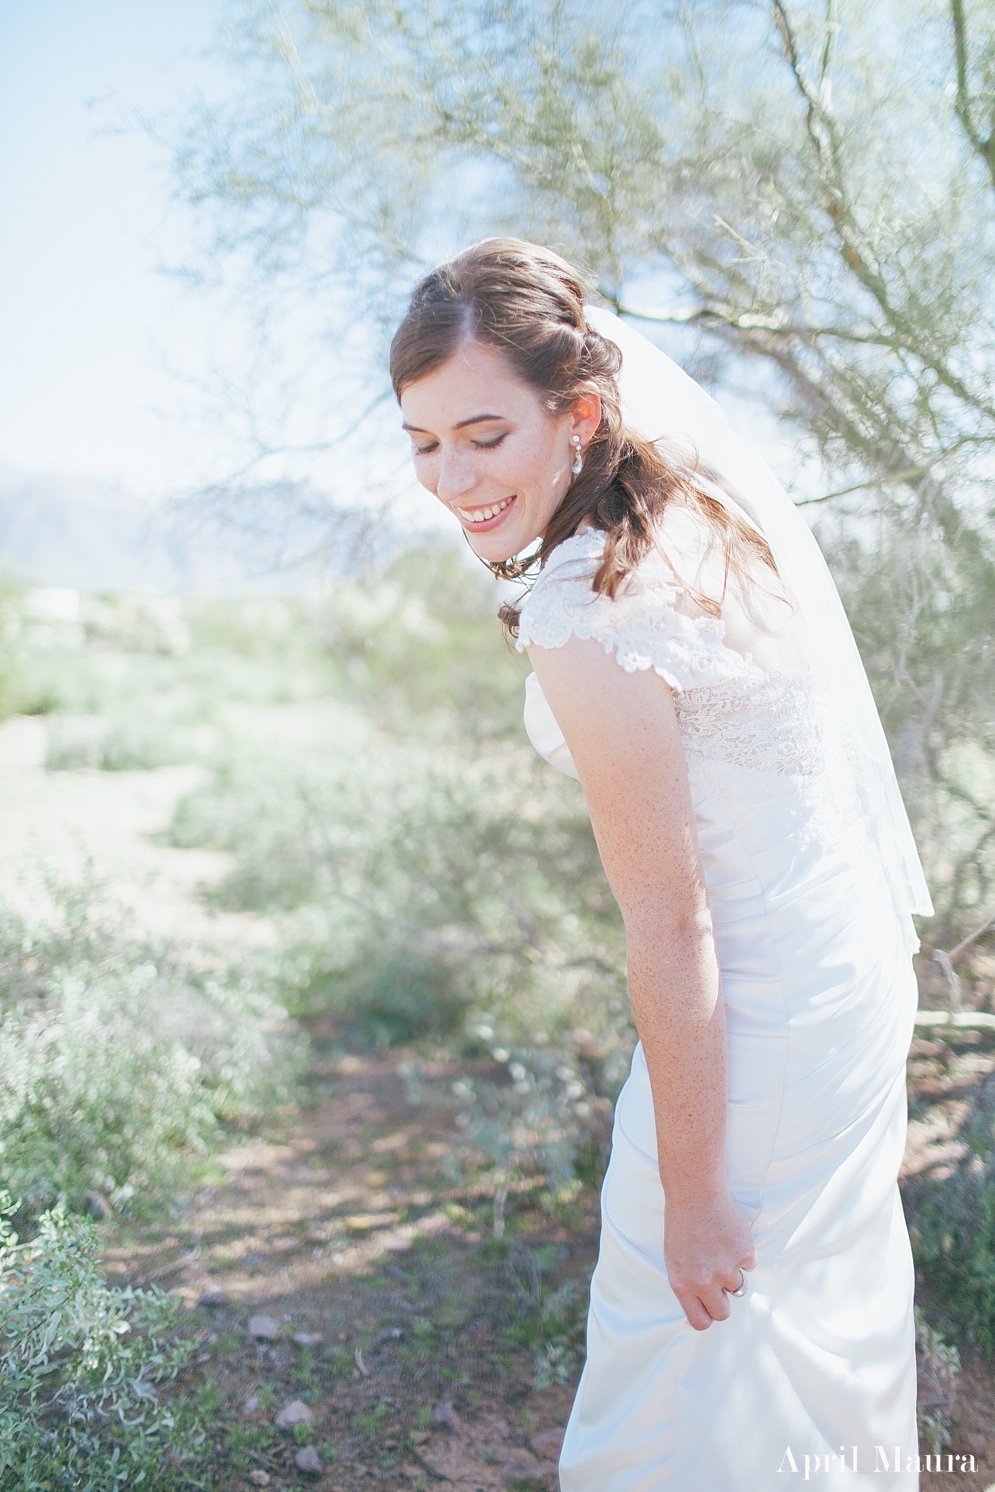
[391,239,931,1492]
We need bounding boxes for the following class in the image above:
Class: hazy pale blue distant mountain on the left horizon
[0,467,328,594]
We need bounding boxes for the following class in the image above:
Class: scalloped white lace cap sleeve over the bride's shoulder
[518,530,741,691]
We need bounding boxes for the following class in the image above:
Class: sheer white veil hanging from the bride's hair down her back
[586,306,932,936]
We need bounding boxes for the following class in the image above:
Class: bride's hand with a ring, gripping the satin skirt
[664,1189,756,1331]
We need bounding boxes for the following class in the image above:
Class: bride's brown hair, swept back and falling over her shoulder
[391,239,776,627]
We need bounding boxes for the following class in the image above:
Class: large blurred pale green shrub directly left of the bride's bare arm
[166,698,633,1199]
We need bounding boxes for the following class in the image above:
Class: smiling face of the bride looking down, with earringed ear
[401,342,601,561]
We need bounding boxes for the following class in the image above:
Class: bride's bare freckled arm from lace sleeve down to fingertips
[530,637,756,1329]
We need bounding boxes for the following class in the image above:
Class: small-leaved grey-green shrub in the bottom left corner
[0,1197,203,1492]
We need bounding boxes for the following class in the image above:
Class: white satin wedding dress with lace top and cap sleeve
[519,510,919,1492]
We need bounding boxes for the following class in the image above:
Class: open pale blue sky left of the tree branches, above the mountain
[0,0,261,495]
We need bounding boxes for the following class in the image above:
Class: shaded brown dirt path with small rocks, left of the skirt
[104,1058,594,1492]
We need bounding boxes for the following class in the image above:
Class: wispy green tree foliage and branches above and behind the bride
[178,0,995,937]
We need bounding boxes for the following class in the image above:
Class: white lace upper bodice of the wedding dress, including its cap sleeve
[518,530,825,777]
